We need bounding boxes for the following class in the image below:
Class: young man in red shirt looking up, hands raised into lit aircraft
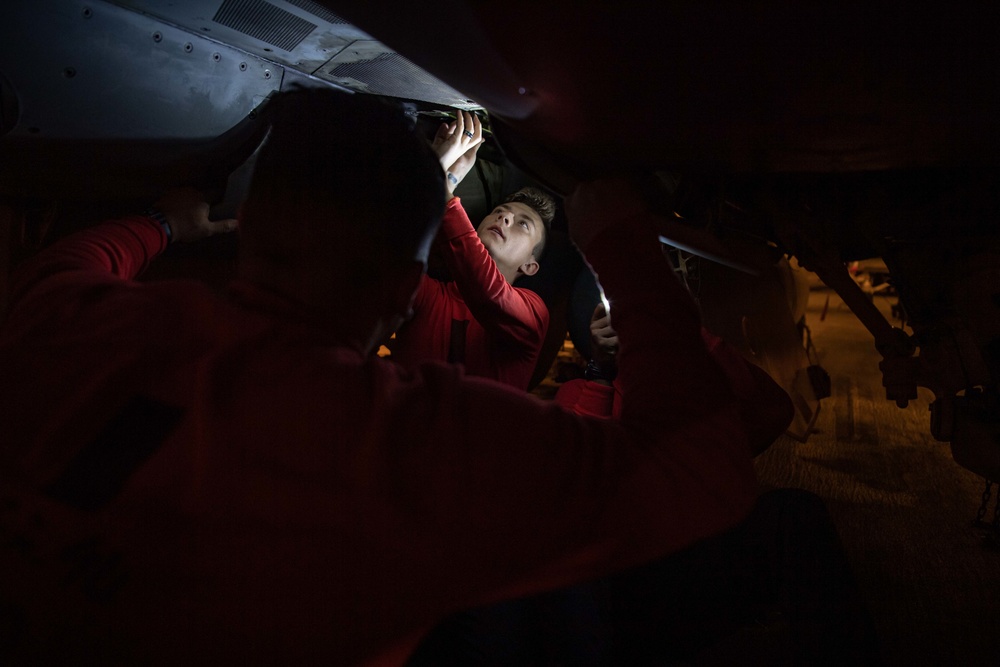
[392,112,555,389]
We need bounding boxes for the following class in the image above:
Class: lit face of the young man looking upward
[476,202,545,277]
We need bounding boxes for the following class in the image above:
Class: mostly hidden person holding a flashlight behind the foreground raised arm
[407,306,882,667]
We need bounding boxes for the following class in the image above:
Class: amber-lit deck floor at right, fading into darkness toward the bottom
[757,288,1000,667]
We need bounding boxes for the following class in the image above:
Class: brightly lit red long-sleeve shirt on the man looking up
[392,197,549,389]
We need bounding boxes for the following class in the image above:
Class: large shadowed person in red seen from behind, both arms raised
[0,91,755,664]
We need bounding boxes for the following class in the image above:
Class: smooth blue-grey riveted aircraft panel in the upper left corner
[0,0,283,140]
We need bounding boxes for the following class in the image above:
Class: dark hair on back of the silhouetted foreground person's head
[240,88,444,277]
